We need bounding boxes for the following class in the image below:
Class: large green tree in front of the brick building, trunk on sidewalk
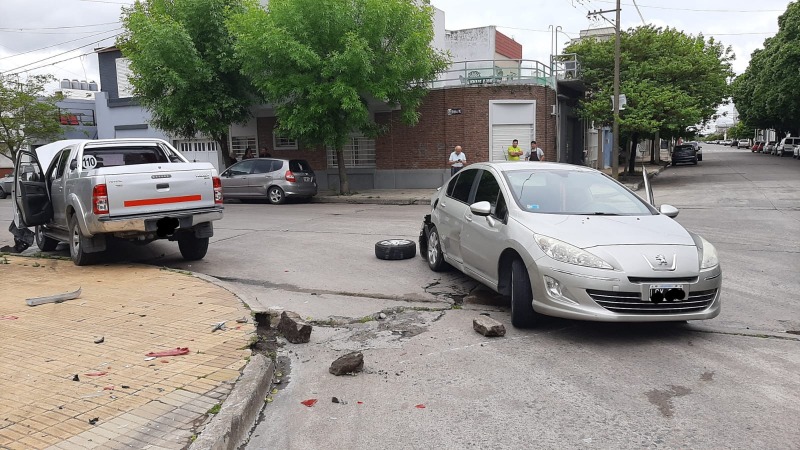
[229,0,448,193]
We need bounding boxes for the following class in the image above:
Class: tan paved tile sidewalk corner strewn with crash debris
[0,256,255,449]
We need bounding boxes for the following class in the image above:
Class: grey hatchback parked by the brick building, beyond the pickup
[220,158,317,205]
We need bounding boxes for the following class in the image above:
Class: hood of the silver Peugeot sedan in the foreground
[521,213,695,249]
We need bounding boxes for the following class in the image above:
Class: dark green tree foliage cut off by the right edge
[733,2,800,134]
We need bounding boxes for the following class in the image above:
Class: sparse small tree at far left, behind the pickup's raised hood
[0,75,63,161]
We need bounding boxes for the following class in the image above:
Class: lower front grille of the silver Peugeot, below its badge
[586,289,717,314]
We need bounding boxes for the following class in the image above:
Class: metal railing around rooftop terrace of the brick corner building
[429,59,555,89]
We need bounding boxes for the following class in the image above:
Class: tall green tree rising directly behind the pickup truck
[118,0,258,165]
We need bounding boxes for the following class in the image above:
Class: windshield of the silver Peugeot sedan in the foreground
[505,169,657,216]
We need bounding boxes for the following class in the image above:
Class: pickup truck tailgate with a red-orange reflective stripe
[100,163,214,217]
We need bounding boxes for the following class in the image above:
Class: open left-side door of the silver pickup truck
[14,150,53,227]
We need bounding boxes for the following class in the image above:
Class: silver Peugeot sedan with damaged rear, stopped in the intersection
[420,162,722,327]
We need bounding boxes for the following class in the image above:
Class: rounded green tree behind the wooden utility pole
[565,26,734,172]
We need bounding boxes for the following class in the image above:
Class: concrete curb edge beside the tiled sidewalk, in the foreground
[189,354,275,450]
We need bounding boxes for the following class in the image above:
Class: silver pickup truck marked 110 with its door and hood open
[14,139,223,266]
